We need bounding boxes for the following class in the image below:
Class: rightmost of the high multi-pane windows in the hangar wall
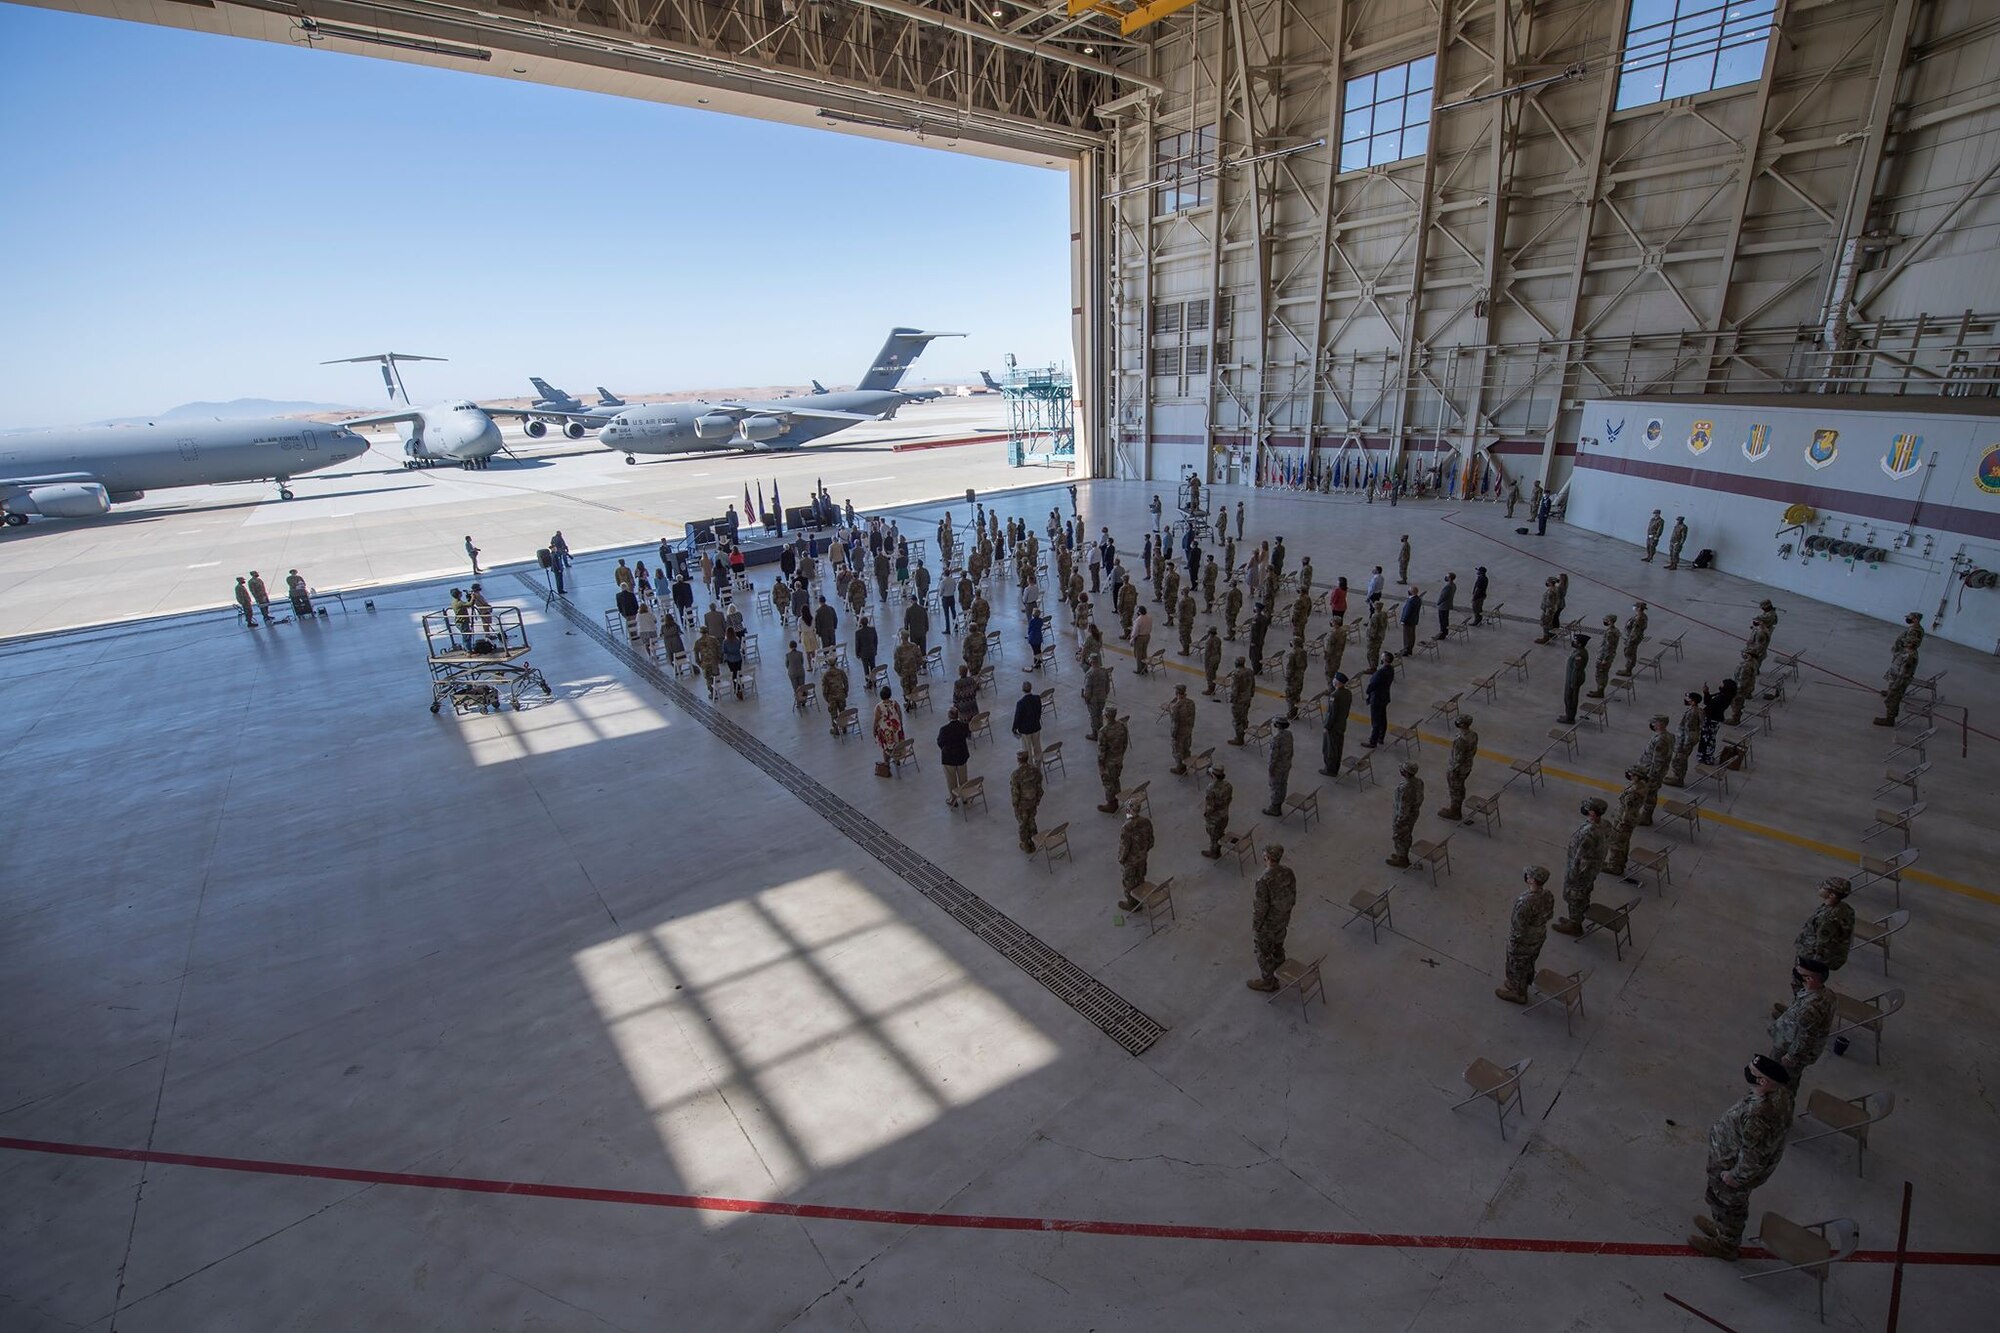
[1618,0,1778,110]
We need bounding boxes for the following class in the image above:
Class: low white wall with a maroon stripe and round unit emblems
[1568,394,2000,648]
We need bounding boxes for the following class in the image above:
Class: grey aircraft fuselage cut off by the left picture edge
[0,418,368,526]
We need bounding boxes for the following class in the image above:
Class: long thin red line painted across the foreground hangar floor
[0,1137,2000,1267]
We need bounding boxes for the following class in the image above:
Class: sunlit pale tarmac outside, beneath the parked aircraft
[0,398,1062,638]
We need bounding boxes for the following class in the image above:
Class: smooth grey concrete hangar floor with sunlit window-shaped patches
[0,474,2000,1331]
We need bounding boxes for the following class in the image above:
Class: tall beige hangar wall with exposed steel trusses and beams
[1098,0,2000,490]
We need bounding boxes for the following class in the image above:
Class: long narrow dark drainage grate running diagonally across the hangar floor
[532,574,1166,1055]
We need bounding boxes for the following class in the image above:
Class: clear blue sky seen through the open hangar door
[0,4,1070,426]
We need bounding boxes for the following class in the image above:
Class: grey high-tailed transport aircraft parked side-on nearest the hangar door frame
[598,328,964,462]
